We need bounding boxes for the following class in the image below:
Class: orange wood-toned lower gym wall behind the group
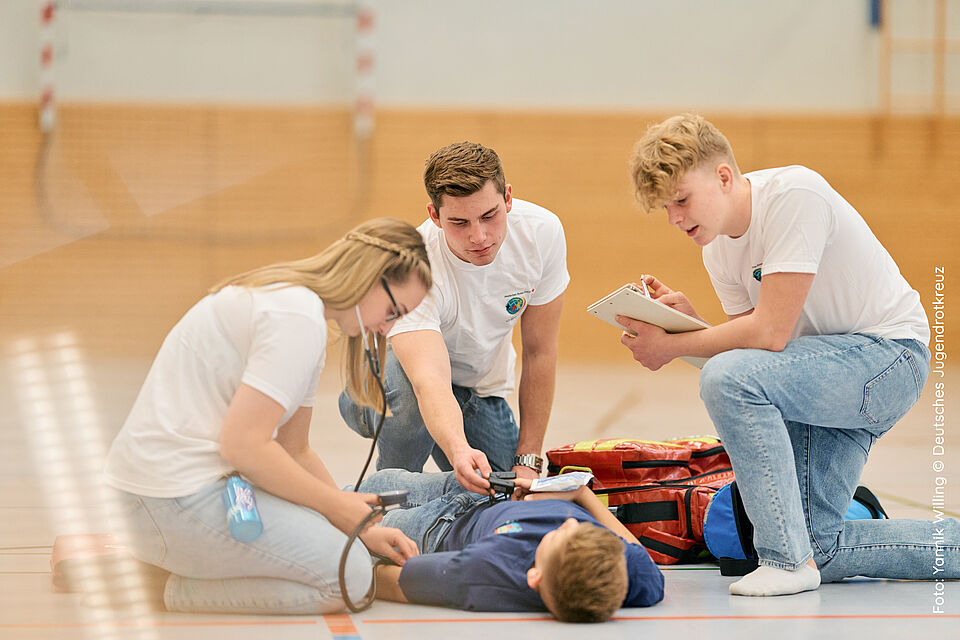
[0,103,960,361]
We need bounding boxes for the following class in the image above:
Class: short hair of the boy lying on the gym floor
[540,522,628,622]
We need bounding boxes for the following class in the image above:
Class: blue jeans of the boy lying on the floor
[360,469,490,553]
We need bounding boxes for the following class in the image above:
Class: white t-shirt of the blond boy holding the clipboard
[703,166,930,343]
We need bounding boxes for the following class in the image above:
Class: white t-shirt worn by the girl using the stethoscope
[106,287,327,498]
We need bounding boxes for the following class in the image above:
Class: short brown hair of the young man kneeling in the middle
[423,142,507,211]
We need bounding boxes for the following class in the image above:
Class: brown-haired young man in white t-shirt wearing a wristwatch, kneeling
[340,142,570,493]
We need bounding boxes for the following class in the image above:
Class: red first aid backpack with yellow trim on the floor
[547,437,734,564]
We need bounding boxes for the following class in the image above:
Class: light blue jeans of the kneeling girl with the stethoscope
[110,479,371,615]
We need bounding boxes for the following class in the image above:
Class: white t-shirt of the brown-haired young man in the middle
[389,198,570,397]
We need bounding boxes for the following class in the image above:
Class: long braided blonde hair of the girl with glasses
[210,218,433,411]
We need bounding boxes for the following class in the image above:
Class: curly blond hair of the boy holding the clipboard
[630,113,740,211]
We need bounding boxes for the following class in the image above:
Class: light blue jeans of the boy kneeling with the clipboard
[700,334,960,582]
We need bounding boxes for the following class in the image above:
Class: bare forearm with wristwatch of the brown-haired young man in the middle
[517,349,557,455]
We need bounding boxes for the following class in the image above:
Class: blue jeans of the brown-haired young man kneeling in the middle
[340,349,519,471]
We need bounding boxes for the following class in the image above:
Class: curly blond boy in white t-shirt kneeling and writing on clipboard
[619,115,960,596]
